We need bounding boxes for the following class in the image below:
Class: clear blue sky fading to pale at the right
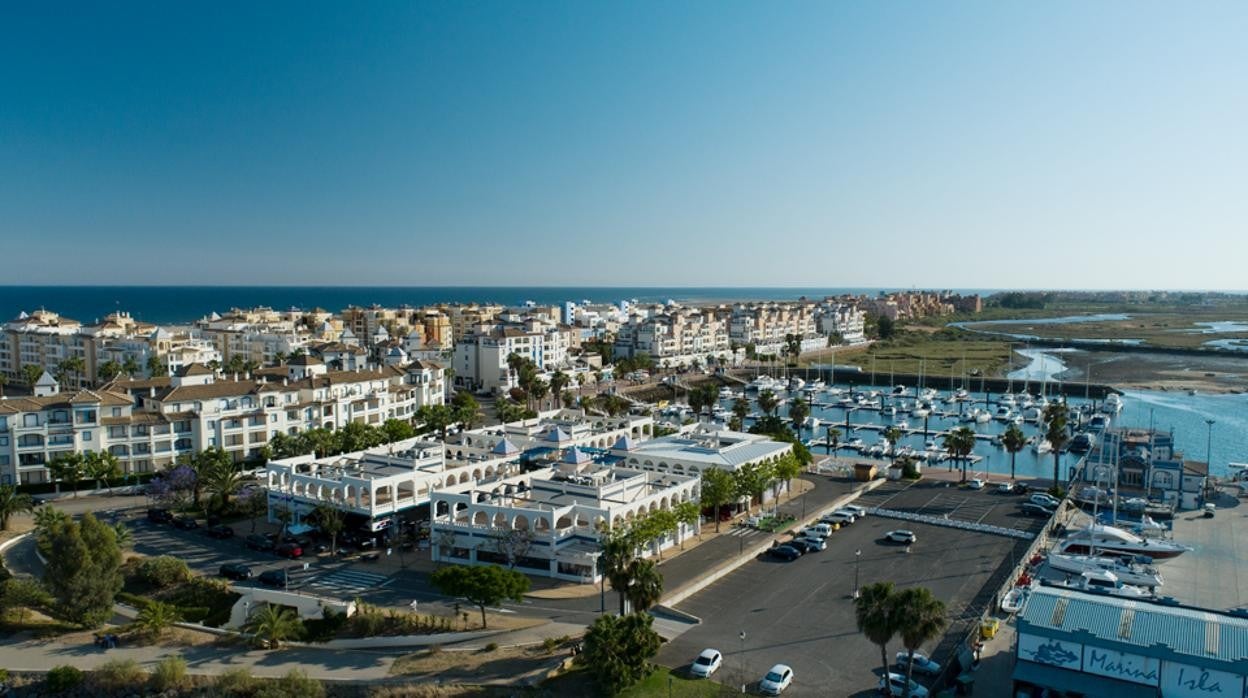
[0,0,1248,290]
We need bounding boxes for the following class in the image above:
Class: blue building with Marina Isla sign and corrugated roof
[1013,587,1248,698]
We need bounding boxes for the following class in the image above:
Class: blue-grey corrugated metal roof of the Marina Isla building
[1018,587,1248,662]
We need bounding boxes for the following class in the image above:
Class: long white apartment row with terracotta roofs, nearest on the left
[0,357,444,483]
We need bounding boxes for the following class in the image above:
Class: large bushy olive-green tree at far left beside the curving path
[40,512,122,628]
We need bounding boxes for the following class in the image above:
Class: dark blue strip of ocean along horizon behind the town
[0,286,992,323]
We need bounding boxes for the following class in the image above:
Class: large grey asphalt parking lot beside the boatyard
[659,482,1045,696]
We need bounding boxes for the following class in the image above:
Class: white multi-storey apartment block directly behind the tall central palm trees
[452,320,574,393]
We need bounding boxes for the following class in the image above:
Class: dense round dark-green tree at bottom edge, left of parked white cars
[579,613,663,696]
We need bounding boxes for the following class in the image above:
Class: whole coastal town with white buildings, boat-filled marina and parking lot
[0,287,1248,696]
